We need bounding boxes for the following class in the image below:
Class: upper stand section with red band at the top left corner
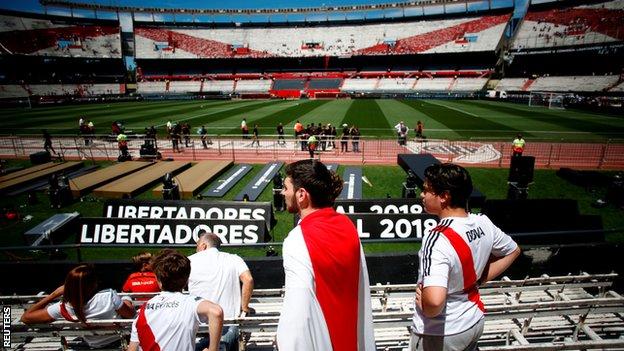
[0,14,121,58]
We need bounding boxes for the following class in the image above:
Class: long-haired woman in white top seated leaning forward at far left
[21,265,135,347]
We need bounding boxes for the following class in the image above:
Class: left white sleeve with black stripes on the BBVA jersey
[420,232,450,288]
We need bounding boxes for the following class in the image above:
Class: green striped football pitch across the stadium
[0,99,624,142]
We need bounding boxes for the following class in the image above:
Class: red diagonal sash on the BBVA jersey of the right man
[440,227,485,312]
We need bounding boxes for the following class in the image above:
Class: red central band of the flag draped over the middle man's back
[300,207,361,351]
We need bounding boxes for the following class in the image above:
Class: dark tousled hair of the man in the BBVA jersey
[425,163,472,208]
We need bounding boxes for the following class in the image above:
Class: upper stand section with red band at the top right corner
[512,0,624,50]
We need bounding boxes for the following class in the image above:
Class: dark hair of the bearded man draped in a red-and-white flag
[286,160,343,208]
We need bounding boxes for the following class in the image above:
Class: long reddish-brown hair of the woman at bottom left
[63,264,98,323]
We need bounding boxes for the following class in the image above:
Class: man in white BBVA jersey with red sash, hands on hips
[410,163,520,350]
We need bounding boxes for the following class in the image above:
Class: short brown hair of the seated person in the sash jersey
[152,249,191,292]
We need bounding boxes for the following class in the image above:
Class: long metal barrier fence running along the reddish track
[0,135,624,169]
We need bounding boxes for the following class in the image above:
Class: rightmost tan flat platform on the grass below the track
[152,161,233,199]
